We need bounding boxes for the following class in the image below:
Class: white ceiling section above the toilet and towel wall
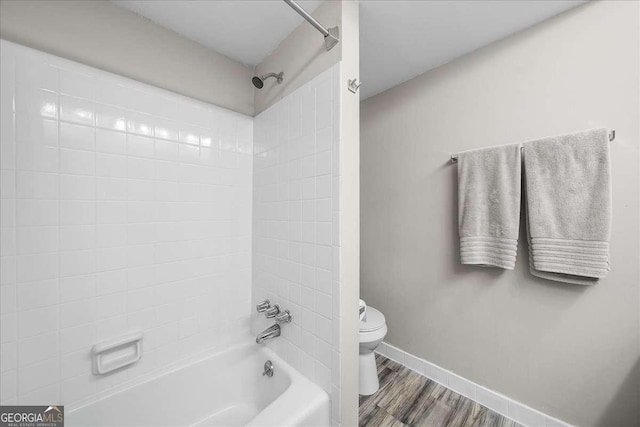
[360,0,584,99]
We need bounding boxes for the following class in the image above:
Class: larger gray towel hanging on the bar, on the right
[524,129,611,284]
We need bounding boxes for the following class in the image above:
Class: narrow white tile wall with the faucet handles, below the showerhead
[252,64,340,424]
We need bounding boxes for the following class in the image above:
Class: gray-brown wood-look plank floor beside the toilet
[359,354,521,427]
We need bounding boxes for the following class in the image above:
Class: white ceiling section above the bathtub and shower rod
[112,0,322,67]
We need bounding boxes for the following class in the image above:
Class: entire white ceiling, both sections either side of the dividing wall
[112,0,584,99]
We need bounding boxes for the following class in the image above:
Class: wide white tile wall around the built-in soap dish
[0,40,255,405]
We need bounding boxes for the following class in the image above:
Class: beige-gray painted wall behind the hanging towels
[361,1,640,426]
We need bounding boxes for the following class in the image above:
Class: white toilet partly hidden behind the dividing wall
[359,306,387,396]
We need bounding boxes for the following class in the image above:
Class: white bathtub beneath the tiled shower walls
[65,338,330,427]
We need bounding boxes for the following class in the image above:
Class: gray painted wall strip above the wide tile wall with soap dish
[0,0,253,115]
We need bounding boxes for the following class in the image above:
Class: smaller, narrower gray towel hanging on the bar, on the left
[458,145,522,270]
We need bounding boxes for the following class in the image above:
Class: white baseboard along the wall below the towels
[376,342,571,427]
